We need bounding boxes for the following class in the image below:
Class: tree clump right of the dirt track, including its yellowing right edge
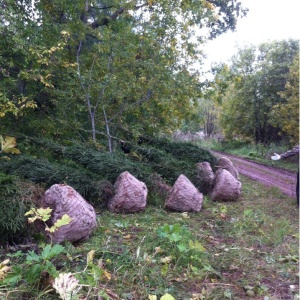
[212,40,299,145]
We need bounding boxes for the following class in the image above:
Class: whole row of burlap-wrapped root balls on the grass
[42,158,241,243]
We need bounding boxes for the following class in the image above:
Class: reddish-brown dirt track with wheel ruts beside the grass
[211,150,297,197]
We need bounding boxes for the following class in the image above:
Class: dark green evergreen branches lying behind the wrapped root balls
[0,139,216,206]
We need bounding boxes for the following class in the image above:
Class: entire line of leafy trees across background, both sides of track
[0,0,299,152]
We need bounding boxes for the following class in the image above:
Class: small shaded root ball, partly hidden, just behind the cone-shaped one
[195,161,215,195]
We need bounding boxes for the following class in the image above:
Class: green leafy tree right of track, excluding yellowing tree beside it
[216,40,299,144]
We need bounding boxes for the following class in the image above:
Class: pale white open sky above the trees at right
[204,0,300,69]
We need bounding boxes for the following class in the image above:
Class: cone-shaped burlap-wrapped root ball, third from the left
[165,174,203,212]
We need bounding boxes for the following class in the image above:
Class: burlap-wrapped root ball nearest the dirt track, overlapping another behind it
[210,169,242,201]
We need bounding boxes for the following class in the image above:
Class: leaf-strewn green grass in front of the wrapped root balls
[0,177,299,300]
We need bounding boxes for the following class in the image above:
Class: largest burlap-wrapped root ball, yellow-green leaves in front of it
[43,184,97,243]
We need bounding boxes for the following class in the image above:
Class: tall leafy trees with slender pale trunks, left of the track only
[0,0,246,151]
